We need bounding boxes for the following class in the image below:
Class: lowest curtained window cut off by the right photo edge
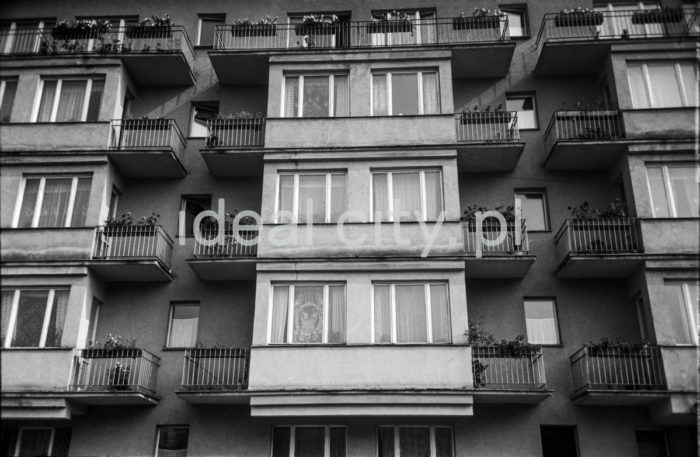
[664,281,700,344]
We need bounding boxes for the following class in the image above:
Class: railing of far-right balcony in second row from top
[544,110,625,151]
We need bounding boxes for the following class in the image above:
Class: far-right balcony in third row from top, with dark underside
[554,218,644,278]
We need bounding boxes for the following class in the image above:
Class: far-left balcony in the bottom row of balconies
[68,349,160,406]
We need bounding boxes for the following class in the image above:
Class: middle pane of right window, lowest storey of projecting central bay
[396,284,428,343]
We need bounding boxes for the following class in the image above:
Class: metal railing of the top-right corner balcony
[536,8,700,48]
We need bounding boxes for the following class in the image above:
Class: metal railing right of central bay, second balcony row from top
[455,111,520,143]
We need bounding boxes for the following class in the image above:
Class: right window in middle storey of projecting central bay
[370,170,443,221]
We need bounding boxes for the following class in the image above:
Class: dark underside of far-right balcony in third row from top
[557,254,644,278]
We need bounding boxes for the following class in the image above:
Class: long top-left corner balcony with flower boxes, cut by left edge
[0,25,195,86]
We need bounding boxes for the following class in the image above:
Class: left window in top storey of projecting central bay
[281,75,350,117]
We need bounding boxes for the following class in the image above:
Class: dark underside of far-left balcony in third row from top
[89,259,173,282]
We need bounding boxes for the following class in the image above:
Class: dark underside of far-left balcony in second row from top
[108,149,187,178]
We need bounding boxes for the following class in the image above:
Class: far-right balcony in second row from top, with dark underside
[544,111,627,170]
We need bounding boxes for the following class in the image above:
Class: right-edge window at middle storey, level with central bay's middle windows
[646,165,700,217]
